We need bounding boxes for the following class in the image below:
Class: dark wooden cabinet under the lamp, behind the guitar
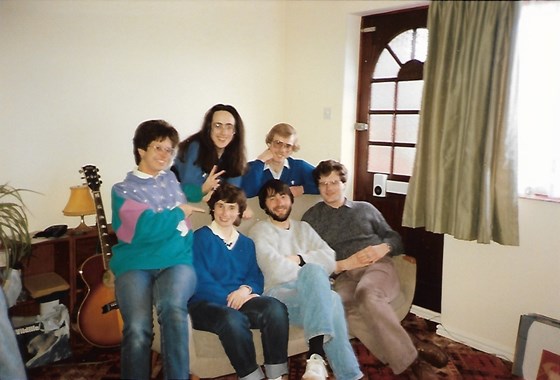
[10,227,112,317]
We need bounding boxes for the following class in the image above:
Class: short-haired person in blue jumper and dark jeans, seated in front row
[189,183,289,380]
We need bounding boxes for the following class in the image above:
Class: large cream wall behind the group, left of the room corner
[0,0,285,229]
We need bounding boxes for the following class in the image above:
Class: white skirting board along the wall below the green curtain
[410,305,513,362]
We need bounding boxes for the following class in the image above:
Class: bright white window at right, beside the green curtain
[516,1,560,199]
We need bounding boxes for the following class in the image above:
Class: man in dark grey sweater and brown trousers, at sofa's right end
[302,160,447,379]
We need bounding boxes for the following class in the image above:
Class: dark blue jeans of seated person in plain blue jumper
[189,296,289,380]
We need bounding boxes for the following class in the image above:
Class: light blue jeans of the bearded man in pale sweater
[266,263,363,380]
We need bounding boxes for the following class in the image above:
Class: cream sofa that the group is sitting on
[152,195,416,379]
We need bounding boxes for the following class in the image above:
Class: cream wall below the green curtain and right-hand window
[439,199,560,360]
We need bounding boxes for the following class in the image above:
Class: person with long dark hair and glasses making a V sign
[171,104,247,202]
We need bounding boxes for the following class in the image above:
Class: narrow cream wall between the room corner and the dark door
[286,1,427,194]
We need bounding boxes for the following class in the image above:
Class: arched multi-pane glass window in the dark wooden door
[367,28,428,178]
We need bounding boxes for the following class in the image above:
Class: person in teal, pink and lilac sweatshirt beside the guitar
[109,120,203,379]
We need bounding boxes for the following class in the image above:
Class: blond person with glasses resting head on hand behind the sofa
[241,123,319,198]
